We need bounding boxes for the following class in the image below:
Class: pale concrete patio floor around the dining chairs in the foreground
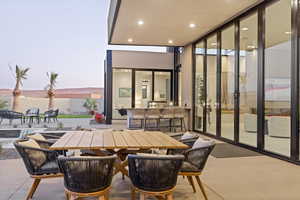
[0,141,300,200]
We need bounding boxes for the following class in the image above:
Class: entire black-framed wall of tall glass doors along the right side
[194,0,300,162]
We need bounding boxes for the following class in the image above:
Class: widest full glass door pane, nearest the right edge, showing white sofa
[265,0,292,156]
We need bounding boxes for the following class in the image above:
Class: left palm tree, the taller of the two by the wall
[12,65,29,111]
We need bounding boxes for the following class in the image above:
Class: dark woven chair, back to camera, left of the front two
[58,156,116,200]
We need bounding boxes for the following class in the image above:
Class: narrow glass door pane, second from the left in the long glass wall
[206,35,217,135]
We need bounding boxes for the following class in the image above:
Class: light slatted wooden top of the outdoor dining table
[50,130,188,150]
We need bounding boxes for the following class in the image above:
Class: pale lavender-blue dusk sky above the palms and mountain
[0,0,109,89]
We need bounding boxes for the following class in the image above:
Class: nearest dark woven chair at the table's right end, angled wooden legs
[179,144,215,200]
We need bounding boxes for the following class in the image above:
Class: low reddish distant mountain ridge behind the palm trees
[0,87,104,99]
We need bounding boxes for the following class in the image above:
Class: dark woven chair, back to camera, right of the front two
[128,154,184,200]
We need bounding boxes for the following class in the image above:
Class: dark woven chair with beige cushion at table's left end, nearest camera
[14,140,62,200]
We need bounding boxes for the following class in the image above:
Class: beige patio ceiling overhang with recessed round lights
[108,0,263,46]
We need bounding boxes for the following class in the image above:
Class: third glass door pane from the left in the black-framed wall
[221,25,235,140]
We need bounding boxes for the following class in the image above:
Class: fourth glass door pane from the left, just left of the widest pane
[239,13,258,147]
